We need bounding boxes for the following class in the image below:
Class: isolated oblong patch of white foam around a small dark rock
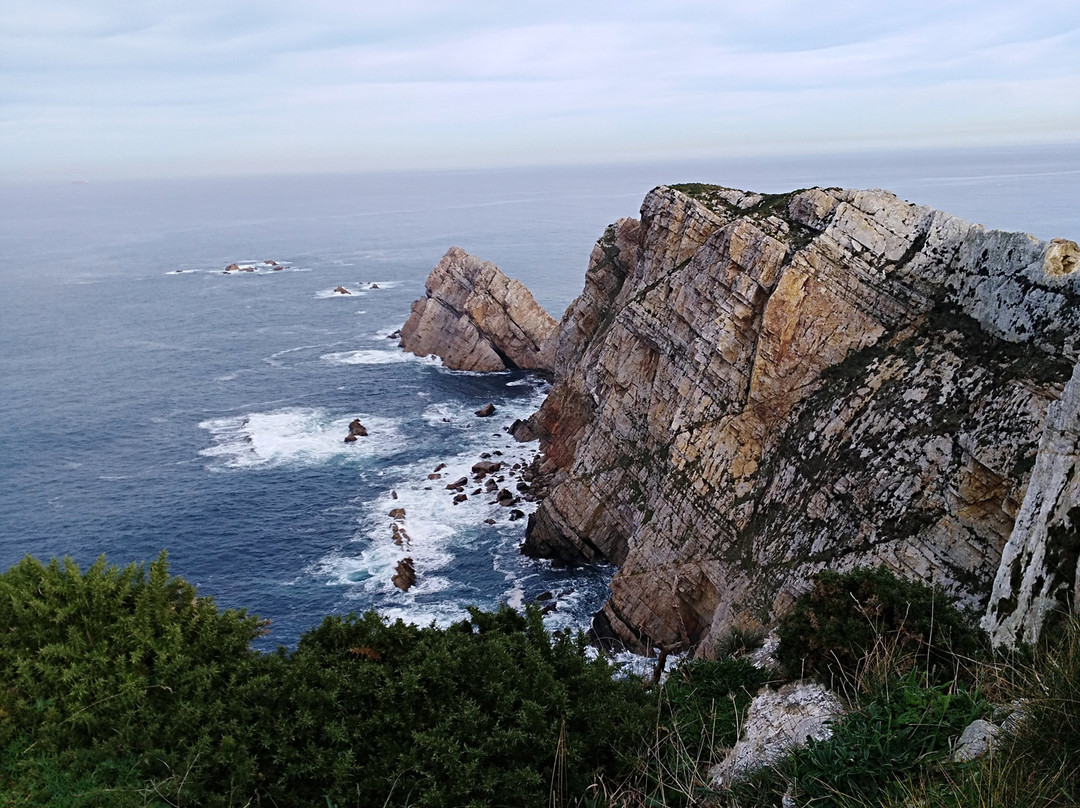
[199,408,401,469]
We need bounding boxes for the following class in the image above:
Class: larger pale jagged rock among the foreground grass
[710,682,843,786]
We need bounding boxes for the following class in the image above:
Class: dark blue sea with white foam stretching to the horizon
[0,146,1080,645]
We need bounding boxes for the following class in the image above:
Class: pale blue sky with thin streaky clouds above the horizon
[0,0,1080,181]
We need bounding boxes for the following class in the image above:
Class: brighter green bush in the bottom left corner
[0,554,261,805]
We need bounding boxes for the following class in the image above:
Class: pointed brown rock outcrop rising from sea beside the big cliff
[401,247,558,373]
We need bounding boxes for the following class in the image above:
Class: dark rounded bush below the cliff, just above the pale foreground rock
[777,567,984,682]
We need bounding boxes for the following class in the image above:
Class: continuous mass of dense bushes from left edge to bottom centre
[0,556,656,808]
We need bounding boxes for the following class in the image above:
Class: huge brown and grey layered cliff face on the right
[524,186,1080,654]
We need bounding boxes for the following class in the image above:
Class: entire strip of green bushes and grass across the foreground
[0,556,1080,808]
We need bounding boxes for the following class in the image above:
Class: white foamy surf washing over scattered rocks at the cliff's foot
[310,394,552,628]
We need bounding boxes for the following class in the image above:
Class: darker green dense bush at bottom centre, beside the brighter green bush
[261,608,650,808]
